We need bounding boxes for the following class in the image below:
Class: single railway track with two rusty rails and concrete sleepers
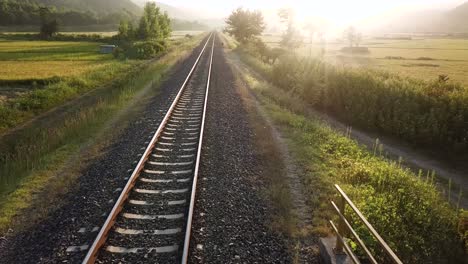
[83,33,215,264]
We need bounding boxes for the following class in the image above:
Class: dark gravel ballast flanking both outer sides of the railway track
[0,33,291,263]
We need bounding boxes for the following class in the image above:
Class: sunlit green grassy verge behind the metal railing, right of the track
[241,71,467,263]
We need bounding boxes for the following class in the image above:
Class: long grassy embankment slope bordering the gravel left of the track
[0,33,205,234]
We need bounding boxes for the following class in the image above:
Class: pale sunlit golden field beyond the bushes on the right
[263,35,468,87]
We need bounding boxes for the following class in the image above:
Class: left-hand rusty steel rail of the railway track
[82,33,213,264]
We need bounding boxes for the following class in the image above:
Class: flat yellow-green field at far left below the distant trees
[0,39,114,81]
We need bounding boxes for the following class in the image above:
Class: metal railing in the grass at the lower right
[330,184,403,264]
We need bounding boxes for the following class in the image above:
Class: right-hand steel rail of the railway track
[181,32,216,264]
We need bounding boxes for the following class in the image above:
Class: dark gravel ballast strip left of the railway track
[0,35,210,263]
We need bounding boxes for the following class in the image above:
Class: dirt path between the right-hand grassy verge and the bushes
[225,47,468,209]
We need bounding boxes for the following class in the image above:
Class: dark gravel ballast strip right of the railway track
[190,35,291,263]
